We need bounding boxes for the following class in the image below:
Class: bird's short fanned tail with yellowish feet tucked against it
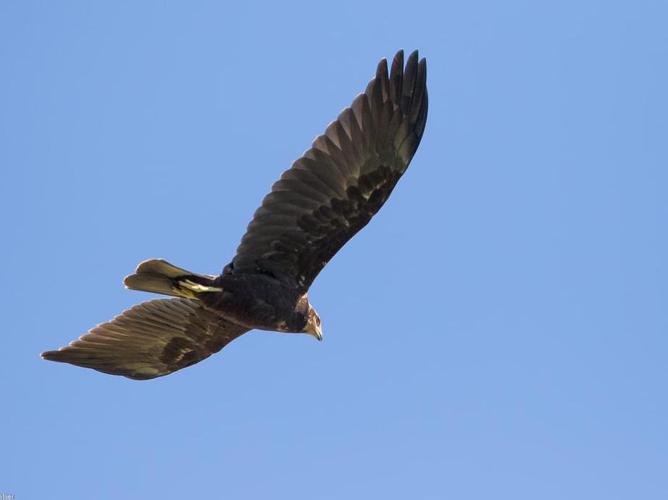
[124,259,223,299]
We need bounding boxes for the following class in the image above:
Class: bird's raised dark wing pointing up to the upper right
[226,51,427,290]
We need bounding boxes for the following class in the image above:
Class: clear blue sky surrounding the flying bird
[0,0,668,500]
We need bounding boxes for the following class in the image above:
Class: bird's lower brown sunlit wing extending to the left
[42,299,248,380]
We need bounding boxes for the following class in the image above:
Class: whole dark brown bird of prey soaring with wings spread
[42,50,428,380]
